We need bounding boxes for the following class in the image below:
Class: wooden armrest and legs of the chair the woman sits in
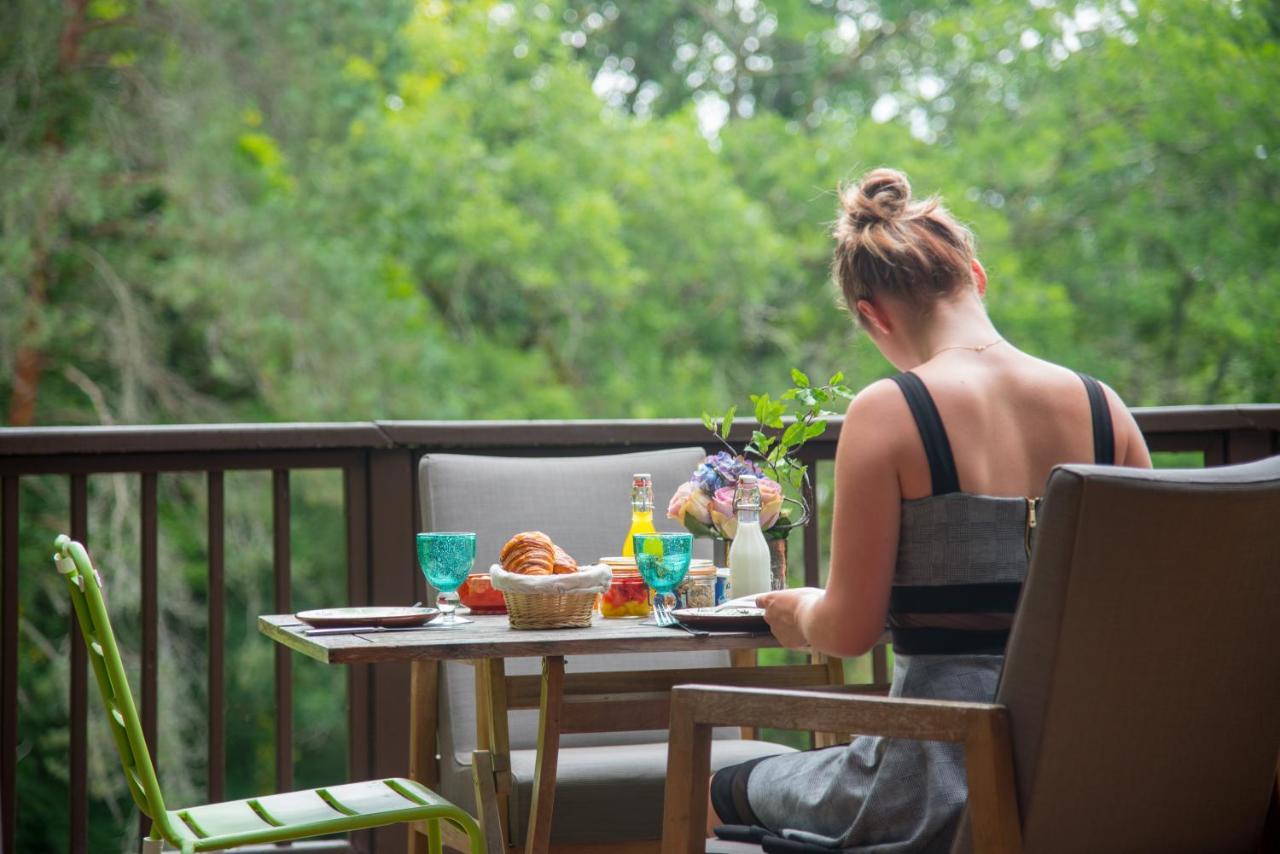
[662,685,1021,854]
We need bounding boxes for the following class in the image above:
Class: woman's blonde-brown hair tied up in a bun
[832,169,974,320]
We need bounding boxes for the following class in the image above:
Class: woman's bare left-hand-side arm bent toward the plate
[756,380,914,657]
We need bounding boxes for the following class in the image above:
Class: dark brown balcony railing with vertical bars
[0,405,1280,854]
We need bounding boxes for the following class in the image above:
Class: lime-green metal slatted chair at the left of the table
[54,534,485,854]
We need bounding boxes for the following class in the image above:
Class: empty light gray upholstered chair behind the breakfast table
[419,448,787,844]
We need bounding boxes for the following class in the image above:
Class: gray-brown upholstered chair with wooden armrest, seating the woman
[663,457,1280,854]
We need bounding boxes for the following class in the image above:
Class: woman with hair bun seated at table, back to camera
[709,169,1151,854]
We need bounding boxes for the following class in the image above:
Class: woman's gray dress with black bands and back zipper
[746,493,1028,854]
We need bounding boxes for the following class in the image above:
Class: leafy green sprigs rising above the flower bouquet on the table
[703,367,854,536]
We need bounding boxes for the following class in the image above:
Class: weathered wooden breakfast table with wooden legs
[259,615,844,854]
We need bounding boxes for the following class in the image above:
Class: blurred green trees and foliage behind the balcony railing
[0,0,1280,851]
